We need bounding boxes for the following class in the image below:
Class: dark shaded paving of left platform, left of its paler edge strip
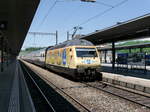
[0,61,16,112]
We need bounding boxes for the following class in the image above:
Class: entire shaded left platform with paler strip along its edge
[0,60,35,112]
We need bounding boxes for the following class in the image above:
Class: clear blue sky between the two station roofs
[22,0,150,49]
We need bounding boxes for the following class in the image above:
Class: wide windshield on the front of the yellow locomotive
[76,48,97,57]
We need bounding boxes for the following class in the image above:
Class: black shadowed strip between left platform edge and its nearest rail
[21,63,56,112]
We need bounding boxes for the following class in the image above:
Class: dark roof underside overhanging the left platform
[0,0,40,56]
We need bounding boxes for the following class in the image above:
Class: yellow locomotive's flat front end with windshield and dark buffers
[75,46,101,79]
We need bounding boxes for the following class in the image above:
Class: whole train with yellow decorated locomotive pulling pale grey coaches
[23,39,101,80]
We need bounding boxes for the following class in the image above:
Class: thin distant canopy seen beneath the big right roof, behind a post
[97,43,150,51]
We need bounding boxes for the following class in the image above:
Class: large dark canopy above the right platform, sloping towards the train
[81,13,150,45]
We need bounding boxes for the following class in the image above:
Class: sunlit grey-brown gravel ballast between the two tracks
[24,62,150,112]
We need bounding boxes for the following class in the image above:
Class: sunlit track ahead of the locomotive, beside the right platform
[84,82,150,108]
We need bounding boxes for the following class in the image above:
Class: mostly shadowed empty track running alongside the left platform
[21,62,91,112]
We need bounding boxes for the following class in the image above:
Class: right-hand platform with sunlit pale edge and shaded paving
[101,64,150,94]
